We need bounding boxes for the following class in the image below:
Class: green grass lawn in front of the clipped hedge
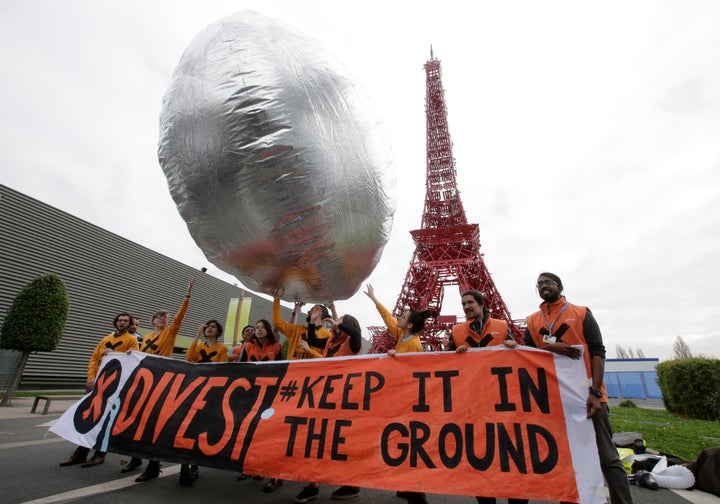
[610,406,720,460]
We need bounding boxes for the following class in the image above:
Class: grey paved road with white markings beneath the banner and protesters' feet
[0,399,720,504]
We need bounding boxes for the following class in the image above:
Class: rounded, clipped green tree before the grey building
[0,273,70,406]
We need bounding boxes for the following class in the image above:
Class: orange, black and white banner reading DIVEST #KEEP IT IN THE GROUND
[51,347,605,504]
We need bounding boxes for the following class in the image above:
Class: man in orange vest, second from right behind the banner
[448,290,528,504]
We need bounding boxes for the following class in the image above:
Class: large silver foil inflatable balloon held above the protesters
[158,12,395,302]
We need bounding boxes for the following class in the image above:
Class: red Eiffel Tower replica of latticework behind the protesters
[369,48,522,353]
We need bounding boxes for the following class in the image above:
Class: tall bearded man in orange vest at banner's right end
[525,272,632,504]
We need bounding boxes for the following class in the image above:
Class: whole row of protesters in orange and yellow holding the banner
[60,272,632,504]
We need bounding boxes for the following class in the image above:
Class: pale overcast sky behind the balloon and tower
[0,0,720,359]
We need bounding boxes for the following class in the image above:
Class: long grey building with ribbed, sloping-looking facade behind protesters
[0,185,290,389]
